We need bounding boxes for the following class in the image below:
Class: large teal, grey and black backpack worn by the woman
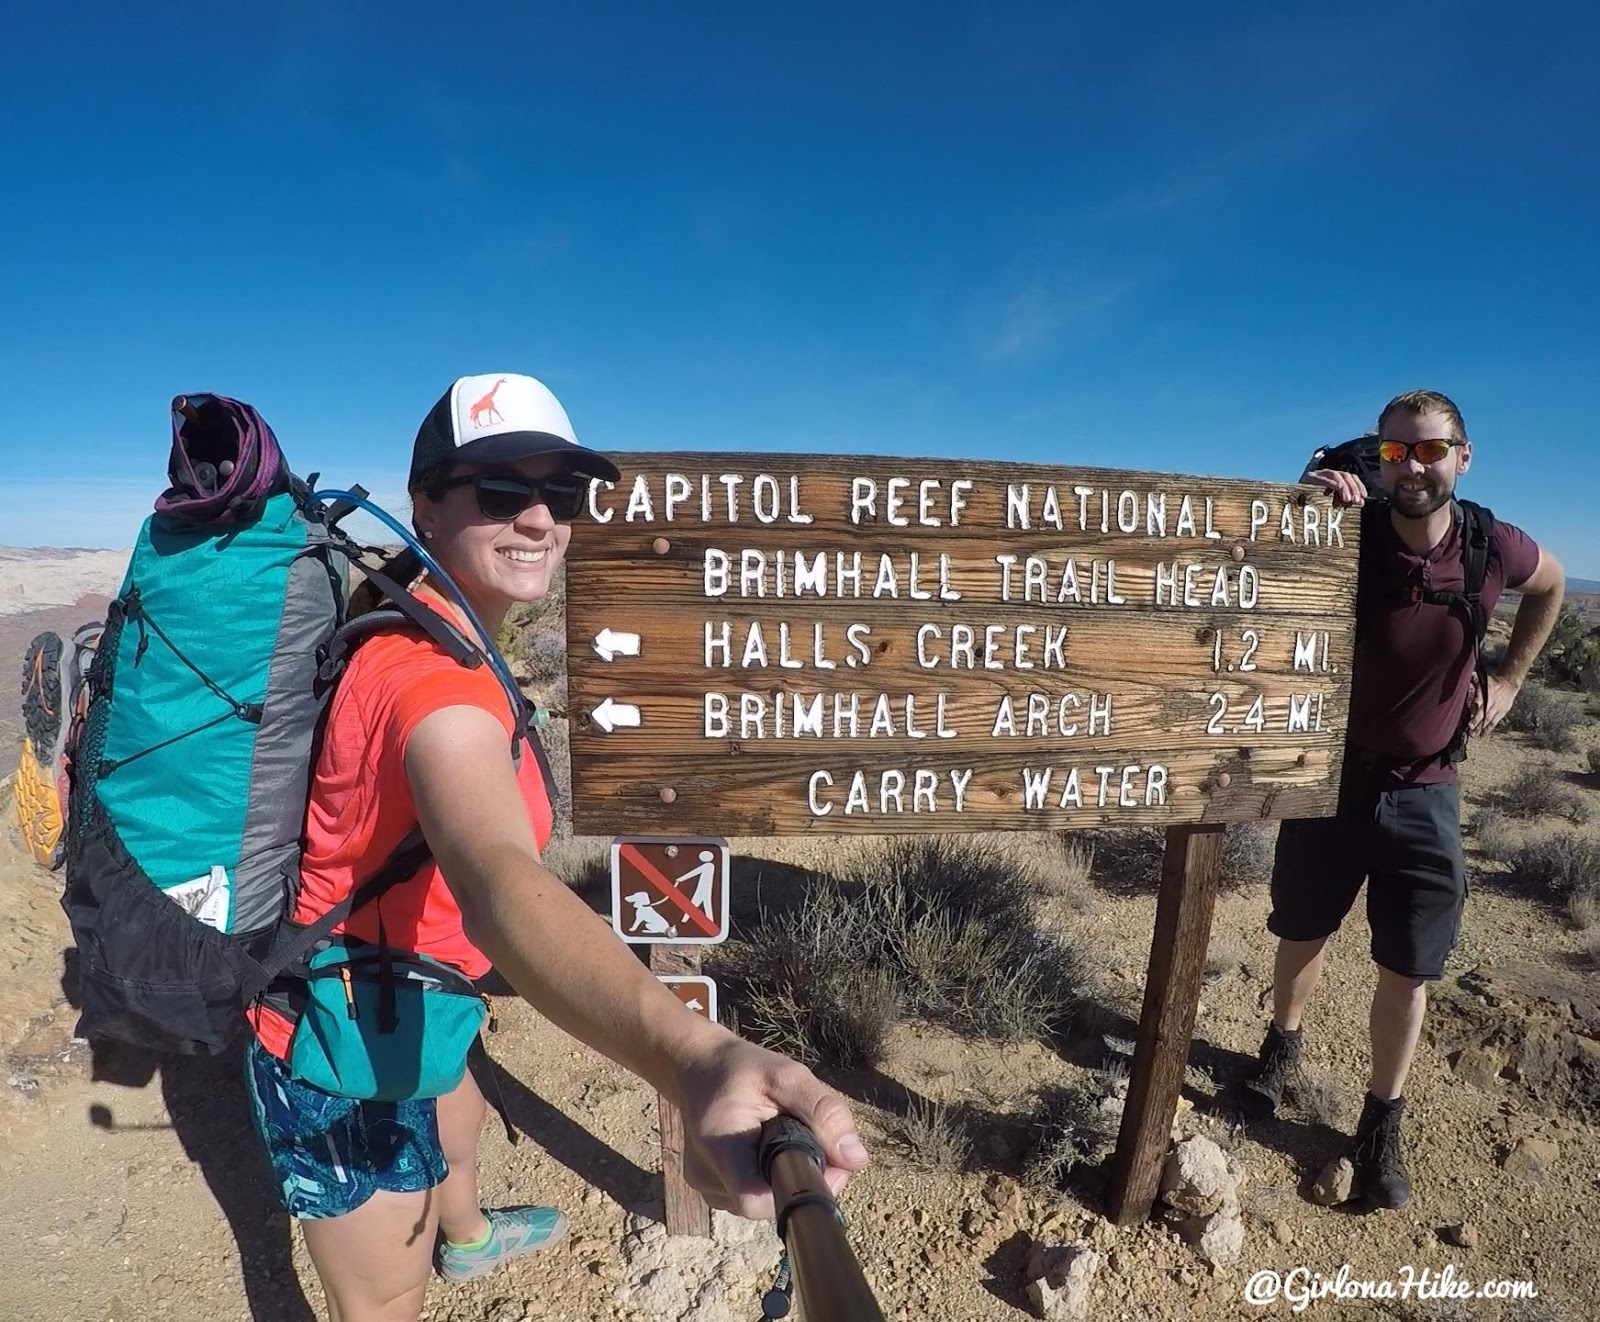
[62,395,554,1098]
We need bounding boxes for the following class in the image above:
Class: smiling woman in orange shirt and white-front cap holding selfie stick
[250,375,867,1322]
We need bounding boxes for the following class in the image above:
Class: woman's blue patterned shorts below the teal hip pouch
[245,1034,450,1220]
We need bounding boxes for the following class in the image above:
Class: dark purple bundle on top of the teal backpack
[155,395,290,523]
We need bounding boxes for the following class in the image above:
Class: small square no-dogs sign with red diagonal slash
[611,837,728,946]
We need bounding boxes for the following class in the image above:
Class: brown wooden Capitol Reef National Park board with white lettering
[568,453,1360,835]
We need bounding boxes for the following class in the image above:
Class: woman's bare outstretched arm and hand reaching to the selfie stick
[405,706,866,1216]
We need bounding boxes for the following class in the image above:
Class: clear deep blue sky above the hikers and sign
[0,0,1600,578]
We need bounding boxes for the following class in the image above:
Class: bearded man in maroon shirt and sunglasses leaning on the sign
[1245,391,1563,1207]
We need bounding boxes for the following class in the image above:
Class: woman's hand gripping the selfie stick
[678,1034,867,1220]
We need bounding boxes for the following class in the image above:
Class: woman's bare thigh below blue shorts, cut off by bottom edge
[301,1189,438,1322]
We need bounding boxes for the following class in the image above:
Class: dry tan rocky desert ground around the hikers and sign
[0,569,1600,1322]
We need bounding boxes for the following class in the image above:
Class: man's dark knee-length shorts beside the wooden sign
[1267,754,1467,981]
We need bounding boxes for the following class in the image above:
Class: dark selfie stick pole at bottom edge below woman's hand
[757,1116,885,1322]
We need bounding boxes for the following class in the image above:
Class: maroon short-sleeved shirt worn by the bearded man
[1350,499,1539,784]
